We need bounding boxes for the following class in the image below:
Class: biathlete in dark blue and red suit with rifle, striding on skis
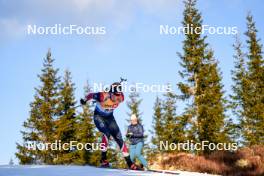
[80,78,141,170]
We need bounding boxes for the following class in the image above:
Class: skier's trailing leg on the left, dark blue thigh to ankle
[94,115,110,162]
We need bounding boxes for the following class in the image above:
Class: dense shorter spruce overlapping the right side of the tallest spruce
[195,52,229,146]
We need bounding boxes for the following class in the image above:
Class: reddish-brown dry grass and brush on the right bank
[150,145,264,176]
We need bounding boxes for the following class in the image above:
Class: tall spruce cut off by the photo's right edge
[241,14,264,145]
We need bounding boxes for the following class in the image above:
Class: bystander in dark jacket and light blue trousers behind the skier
[126,114,148,169]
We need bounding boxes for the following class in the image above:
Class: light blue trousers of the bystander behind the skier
[129,142,148,167]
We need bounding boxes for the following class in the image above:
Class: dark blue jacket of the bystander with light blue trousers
[127,124,144,145]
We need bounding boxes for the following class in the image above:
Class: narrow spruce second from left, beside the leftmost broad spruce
[54,70,76,164]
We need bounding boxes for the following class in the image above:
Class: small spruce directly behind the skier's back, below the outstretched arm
[74,81,100,166]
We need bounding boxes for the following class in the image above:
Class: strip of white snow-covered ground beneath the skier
[0,165,219,176]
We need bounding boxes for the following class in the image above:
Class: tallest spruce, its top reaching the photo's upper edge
[178,0,207,145]
